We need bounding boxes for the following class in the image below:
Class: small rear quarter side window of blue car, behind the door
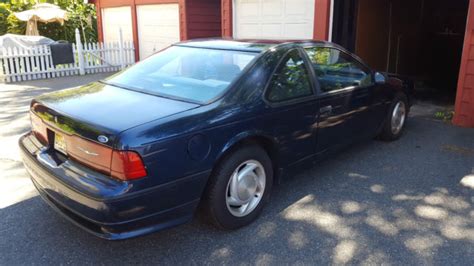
[267,50,313,102]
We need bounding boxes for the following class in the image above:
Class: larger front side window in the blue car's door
[305,47,372,92]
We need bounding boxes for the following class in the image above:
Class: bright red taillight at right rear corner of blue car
[110,150,147,180]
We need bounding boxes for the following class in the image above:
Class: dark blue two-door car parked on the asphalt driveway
[20,40,411,239]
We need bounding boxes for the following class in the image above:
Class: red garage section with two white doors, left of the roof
[92,0,222,61]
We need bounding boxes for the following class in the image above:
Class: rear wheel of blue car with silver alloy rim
[203,145,273,230]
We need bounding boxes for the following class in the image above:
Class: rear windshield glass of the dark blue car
[106,46,257,103]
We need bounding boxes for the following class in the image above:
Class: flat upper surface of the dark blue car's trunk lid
[31,83,198,143]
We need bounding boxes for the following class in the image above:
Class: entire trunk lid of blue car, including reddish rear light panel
[30,83,198,178]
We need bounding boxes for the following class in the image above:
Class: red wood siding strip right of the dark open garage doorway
[453,0,474,127]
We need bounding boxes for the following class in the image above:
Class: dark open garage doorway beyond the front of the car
[333,0,469,106]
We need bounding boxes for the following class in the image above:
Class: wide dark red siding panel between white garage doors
[186,0,221,39]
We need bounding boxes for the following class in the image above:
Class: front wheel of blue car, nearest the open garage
[379,93,409,141]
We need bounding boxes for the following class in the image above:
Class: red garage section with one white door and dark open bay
[221,0,474,127]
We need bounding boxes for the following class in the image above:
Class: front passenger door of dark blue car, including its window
[305,46,377,153]
